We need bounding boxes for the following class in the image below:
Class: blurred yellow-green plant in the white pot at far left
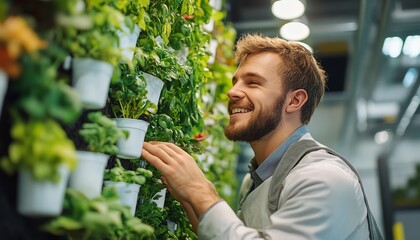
[0,118,76,182]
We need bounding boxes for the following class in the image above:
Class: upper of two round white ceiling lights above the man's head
[271,0,305,20]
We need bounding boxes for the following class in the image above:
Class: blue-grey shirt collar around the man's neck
[250,125,308,185]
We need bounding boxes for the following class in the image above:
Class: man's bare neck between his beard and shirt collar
[250,123,301,165]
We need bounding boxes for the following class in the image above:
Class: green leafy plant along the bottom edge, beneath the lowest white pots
[42,188,154,240]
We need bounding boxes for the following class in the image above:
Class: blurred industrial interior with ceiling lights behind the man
[227,0,420,240]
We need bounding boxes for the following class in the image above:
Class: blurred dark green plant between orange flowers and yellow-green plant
[11,44,82,124]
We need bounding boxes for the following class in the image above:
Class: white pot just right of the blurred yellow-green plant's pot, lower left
[69,151,109,198]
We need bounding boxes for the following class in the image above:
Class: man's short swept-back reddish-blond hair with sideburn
[235,34,327,124]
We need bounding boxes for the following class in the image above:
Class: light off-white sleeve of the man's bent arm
[198,153,369,240]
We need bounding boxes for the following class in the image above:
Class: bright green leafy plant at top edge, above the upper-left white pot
[56,0,126,66]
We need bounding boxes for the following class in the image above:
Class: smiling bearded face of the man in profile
[225,53,285,142]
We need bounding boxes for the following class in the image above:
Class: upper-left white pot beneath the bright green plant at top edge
[73,58,114,109]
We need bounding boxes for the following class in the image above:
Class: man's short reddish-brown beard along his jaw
[225,94,286,142]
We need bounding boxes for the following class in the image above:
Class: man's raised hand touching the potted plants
[142,142,220,218]
